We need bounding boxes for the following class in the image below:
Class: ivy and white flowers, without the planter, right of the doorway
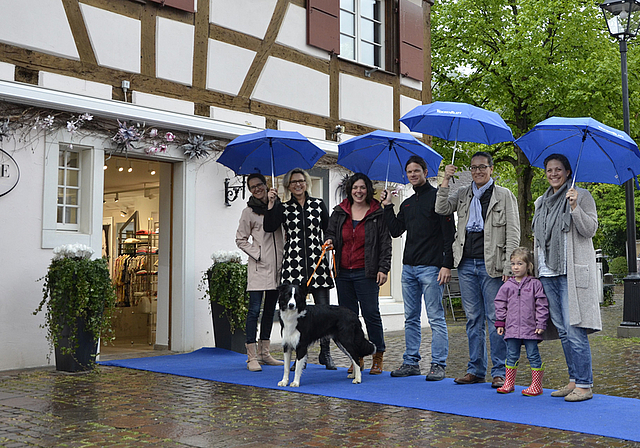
[203,251,249,332]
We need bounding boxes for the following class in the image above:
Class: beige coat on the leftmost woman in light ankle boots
[236,207,284,291]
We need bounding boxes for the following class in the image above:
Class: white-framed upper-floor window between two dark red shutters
[340,0,384,68]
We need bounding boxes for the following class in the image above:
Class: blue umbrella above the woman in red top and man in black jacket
[338,131,442,189]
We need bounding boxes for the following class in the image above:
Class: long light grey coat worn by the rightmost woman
[534,187,602,332]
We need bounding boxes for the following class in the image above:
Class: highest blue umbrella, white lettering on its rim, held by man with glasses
[400,101,513,163]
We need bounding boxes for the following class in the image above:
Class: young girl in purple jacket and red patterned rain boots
[495,247,549,397]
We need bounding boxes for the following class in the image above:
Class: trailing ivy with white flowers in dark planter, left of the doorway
[33,244,116,372]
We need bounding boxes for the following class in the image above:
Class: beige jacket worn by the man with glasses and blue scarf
[436,184,520,278]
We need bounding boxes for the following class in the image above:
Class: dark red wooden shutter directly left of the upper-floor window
[307,0,340,54]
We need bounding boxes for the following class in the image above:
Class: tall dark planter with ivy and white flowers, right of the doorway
[204,251,249,353]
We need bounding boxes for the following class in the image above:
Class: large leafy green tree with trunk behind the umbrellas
[431,0,639,246]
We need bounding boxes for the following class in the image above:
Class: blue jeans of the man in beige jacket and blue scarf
[458,258,507,378]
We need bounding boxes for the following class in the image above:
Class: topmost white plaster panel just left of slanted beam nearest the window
[209,0,276,39]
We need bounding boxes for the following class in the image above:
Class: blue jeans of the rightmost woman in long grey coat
[540,275,593,388]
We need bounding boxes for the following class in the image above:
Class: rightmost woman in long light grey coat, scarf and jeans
[533,154,602,402]
